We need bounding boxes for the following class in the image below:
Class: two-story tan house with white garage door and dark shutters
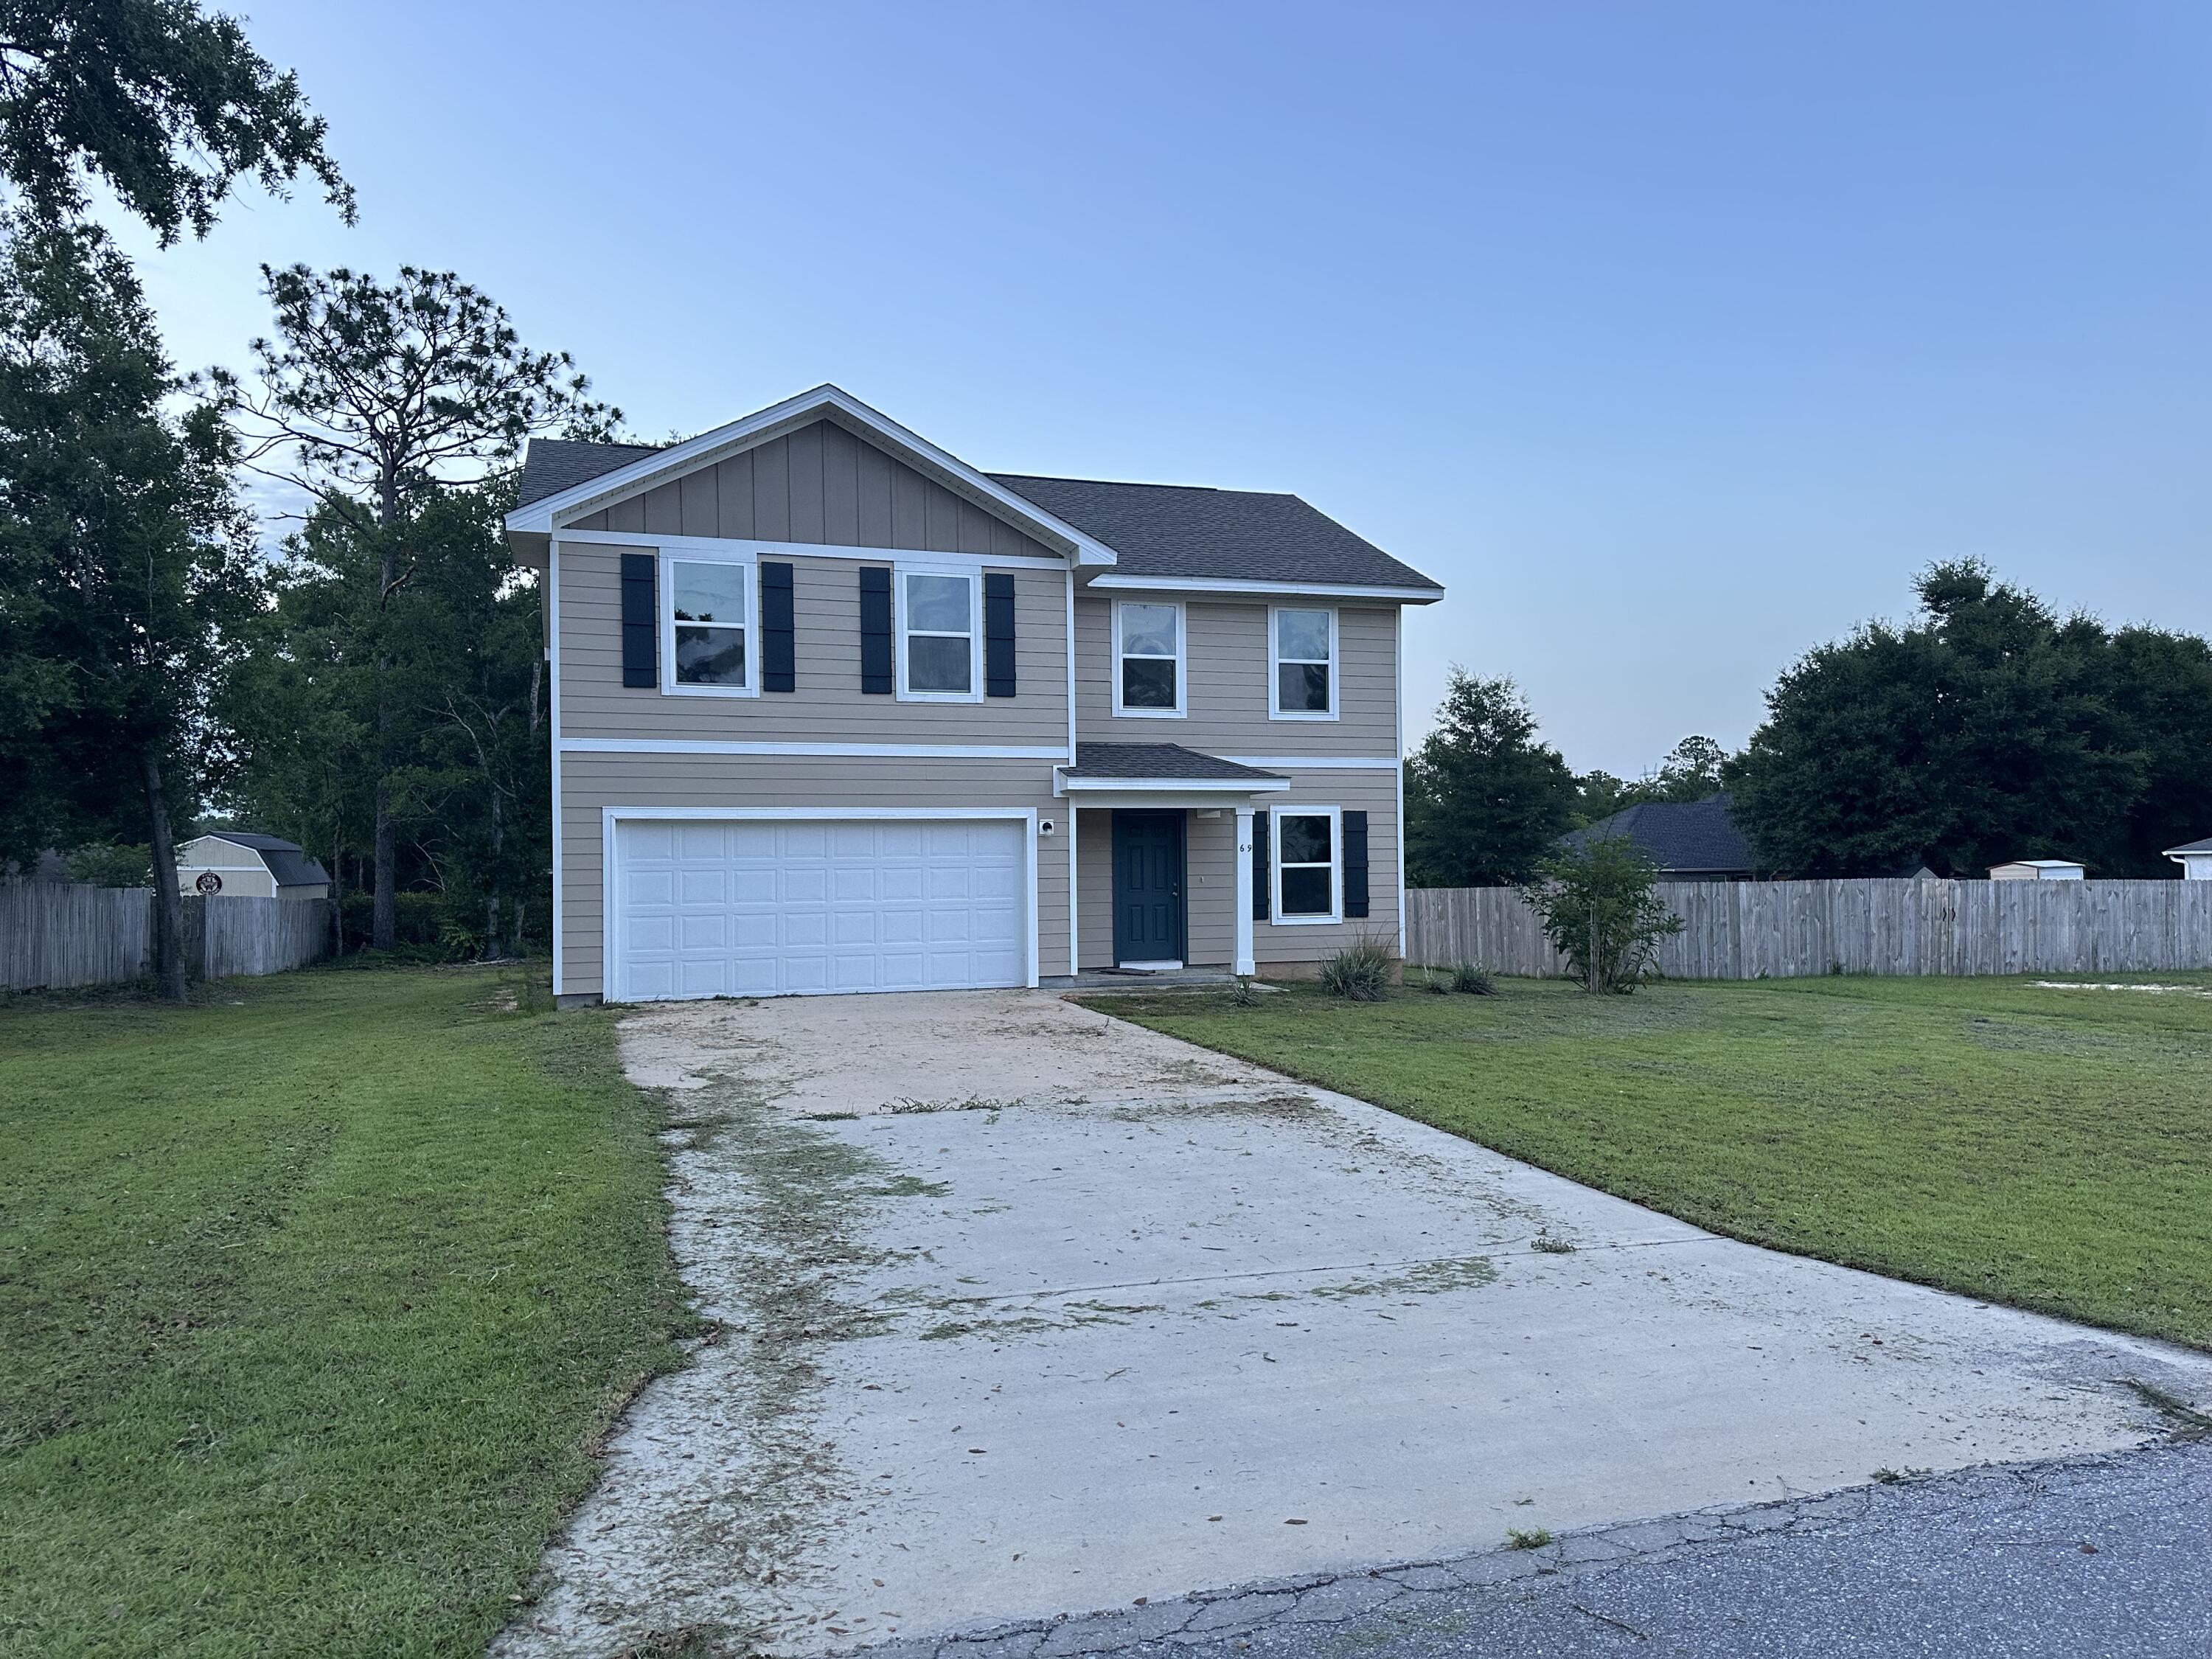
[507,387,1442,1006]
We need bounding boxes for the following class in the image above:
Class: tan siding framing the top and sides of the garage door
[560,752,1068,995]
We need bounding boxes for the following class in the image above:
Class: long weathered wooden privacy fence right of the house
[1405,880,2212,980]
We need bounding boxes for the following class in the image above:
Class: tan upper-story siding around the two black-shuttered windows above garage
[555,542,1068,750]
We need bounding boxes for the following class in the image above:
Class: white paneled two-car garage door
[611,818,1029,1002]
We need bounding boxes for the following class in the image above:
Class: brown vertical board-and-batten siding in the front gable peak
[573,420,1055,560]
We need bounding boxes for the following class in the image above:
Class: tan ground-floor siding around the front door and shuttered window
[1075,768,1400,975]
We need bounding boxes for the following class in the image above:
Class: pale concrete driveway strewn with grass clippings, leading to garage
[495,993,2212,1655]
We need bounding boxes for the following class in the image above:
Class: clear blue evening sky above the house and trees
[116,0,2212,774]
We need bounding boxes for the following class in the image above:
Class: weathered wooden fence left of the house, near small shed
[0,880,330,991]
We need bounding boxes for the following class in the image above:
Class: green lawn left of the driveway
[0,969,688,1659]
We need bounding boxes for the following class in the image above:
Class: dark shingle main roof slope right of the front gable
[991,473,1442,593]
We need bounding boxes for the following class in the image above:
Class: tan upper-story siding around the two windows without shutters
[1075,593,1398,754]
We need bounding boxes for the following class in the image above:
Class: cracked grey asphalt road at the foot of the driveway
[867,1442,2212,1659]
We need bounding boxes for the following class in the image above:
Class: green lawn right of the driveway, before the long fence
[1097,973,2212,1347]
